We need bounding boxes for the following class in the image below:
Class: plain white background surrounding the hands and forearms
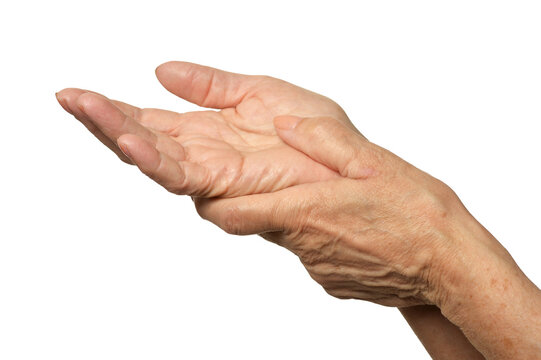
[0,0,541,360]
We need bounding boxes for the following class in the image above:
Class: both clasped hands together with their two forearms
[57,62,541,359]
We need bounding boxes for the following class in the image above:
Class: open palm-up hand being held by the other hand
[57,62,354,197]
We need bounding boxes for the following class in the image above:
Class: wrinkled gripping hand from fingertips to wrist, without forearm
[196,116,474,306]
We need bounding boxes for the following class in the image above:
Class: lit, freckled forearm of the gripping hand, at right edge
[432,212,541,359]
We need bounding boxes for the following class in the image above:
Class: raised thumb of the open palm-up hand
[156,61,262,109]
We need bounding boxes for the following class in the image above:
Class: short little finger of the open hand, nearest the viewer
[118,134,210,195]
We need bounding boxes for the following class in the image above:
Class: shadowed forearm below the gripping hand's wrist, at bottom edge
[399,305,484,360]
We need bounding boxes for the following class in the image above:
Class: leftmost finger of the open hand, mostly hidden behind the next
[56,89,131,164]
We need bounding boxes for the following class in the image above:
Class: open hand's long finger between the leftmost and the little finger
[77,93,185,160]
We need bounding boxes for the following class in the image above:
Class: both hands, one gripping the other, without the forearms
[53,62,460,306]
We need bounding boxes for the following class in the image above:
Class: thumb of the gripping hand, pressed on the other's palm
[274,115,379,179]
